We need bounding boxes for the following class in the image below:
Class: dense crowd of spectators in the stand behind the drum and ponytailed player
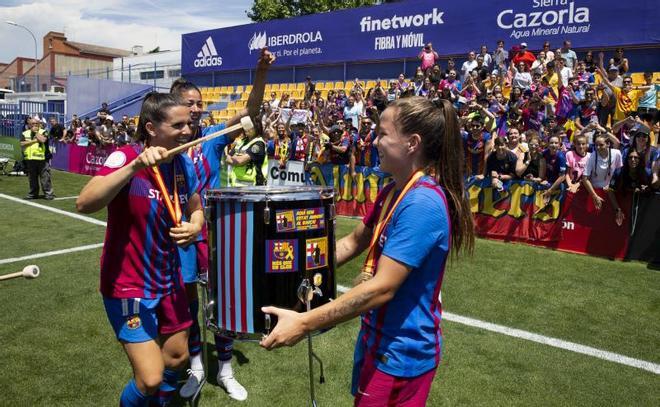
[238,41,660,223]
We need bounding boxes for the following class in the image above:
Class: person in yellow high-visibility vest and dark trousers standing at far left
[21,119,55,200]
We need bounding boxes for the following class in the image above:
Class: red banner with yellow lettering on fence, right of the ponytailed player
[467,180,630,259]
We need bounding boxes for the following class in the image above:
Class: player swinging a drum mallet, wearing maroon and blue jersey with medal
[76,92,204,406]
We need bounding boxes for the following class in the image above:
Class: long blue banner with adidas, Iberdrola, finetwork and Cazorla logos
[181,0,660,75]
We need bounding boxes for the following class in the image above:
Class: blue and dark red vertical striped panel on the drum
[216,202,254,333]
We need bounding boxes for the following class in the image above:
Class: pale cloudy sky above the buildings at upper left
[0,0,252,63]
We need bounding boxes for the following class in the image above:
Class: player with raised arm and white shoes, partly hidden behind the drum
[170,48,275,400]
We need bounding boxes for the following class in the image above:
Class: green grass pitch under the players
[0,171,660,406]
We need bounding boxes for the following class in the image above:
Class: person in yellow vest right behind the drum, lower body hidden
[227,133,268,186]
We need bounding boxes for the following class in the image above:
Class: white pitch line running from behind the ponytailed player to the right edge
[337,284,660,374]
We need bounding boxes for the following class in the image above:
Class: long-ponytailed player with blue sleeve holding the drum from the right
[261,97,474,407]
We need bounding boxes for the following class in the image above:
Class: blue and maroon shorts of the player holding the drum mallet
[103,288,192,343]
